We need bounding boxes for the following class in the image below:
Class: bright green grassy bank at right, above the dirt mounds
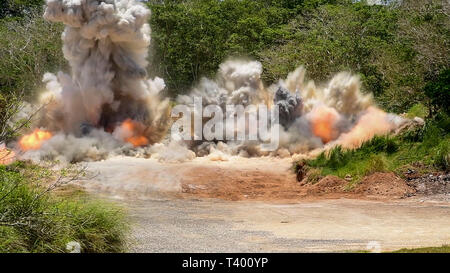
[305,116,450,186]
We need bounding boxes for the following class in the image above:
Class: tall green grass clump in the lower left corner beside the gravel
[0,163,128,252]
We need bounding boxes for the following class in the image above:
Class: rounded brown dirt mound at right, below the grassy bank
[354,173,415,198]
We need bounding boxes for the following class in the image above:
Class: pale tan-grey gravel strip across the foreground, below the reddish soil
[111,198,450,252]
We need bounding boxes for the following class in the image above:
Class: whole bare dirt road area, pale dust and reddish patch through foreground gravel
[79,158,450,252]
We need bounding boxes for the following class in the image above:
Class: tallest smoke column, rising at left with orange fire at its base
[15,0,169,160]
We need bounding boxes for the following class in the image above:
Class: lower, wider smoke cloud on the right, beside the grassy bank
[178,60,405,156]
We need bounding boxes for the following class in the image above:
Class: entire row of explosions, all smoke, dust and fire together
[9,0,412,162]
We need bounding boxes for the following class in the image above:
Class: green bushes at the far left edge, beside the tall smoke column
[0,9,65,144]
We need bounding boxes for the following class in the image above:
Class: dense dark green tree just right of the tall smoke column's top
[149,0,293,95]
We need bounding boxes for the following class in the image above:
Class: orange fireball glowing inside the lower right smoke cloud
[310,106,339,143]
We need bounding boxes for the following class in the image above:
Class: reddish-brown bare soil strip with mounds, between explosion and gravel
[182,166,414,201]
